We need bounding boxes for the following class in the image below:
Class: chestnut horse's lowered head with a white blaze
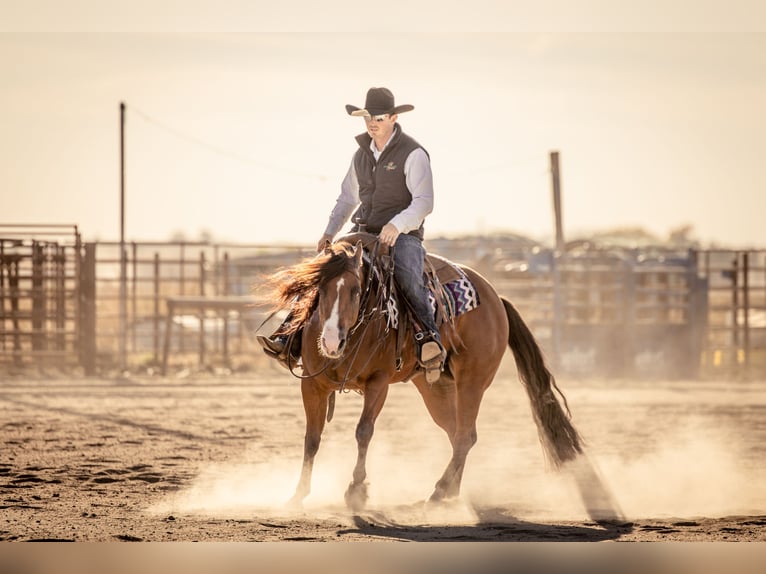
[317,241,364,359]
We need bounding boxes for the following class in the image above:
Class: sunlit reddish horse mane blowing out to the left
[267,241,362,335]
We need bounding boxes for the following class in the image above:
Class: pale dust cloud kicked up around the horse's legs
[151,379,766,524]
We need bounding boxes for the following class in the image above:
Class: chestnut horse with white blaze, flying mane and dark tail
[272,234,582,511]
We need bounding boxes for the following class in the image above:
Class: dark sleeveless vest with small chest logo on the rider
[352,124,428,239]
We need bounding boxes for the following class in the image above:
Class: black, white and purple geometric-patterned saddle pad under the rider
[385,254,480,329]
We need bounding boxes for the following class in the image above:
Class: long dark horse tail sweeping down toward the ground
[501,297,582,468]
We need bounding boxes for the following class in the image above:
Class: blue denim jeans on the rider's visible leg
[394,233,441,340]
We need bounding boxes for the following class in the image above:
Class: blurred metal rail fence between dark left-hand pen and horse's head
[91,242,316,368]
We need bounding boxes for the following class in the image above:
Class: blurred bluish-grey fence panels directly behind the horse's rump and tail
[494,250,706,377]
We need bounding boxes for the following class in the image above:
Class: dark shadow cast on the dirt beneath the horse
[338,505,633,542]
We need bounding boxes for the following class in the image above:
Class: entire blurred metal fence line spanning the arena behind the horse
[0,225,766,378]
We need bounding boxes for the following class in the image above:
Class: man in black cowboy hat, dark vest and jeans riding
[258,88,446,383]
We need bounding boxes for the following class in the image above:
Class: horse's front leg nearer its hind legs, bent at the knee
[345,377,388,512]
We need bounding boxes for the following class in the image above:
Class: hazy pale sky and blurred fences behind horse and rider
[0,7,766,378]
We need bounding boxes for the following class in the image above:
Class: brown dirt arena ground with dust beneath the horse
[0,363,766,542]
